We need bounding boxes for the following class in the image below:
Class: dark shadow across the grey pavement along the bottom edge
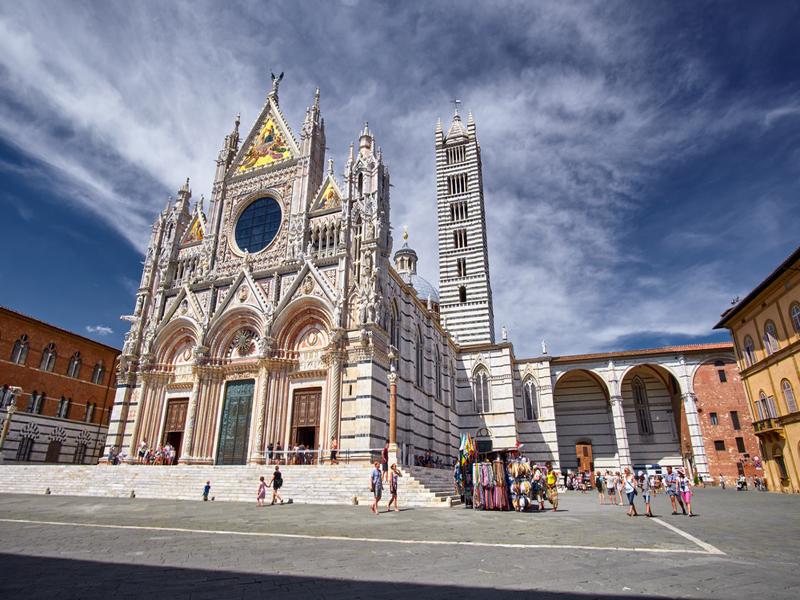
[0,554,700,600]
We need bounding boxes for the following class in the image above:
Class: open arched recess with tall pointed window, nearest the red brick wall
[619,363,680,468]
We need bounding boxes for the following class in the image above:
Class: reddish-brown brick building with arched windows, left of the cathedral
[0,307,119,464]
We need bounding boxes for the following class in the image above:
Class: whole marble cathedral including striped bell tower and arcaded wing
[106,78,733,475]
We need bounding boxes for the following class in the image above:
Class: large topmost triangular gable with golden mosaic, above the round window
[233,97,300,175]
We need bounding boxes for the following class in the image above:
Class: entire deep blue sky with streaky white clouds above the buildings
[0,0,800,356]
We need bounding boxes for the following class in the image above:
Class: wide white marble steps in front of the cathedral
[0,464,458,507]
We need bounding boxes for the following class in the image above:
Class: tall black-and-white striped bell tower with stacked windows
[436,105,494,345]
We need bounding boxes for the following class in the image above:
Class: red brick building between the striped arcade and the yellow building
[694,359,763,484]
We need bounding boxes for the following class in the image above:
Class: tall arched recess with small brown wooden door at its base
[553,369,619,472]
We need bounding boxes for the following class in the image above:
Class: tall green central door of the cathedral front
[217,379,255,465]
